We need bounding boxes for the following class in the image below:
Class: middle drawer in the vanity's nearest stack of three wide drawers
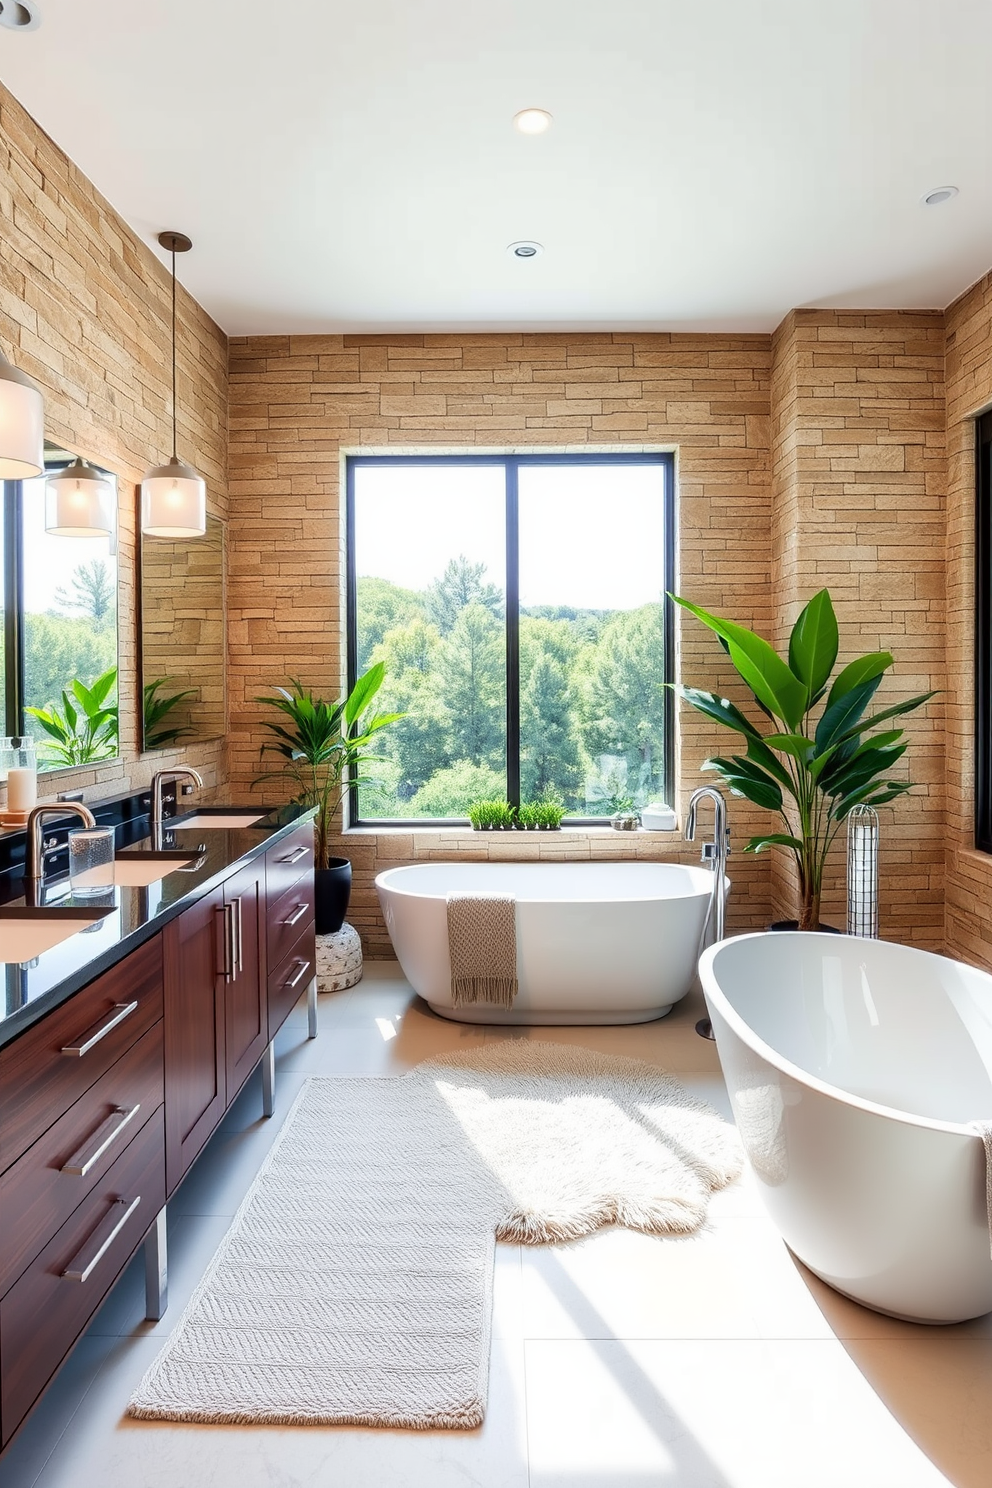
[0,1022,165,1296]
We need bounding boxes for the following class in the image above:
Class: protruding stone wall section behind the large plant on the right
[772,310,946,949]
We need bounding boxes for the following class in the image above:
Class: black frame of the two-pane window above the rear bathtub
[345,449,677,832]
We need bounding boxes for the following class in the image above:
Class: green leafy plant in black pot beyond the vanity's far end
[253,662,405,934]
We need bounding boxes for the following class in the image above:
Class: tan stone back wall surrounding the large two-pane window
[229,333,773,955]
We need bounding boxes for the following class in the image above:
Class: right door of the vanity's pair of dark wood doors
[225,862,269,1104]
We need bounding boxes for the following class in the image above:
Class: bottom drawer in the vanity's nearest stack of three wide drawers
[0,1107,165,1442]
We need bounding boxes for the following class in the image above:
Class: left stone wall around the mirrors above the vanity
[0,86,228,796]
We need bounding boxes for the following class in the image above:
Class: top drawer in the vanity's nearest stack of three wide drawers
[0,936,162,1173]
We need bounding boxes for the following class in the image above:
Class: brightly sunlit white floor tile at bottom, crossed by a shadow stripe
[525,1341,949,1488]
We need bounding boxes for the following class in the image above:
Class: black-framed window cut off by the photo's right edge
[974,411,992,853]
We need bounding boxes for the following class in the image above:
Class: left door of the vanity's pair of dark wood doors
[164,888,228,1193]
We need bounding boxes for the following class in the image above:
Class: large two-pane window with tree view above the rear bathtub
[348,454,674,821]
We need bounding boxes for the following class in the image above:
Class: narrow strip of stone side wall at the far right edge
[944,274,992,970]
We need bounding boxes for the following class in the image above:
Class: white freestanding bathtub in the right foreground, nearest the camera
[699,934,992,1323]
